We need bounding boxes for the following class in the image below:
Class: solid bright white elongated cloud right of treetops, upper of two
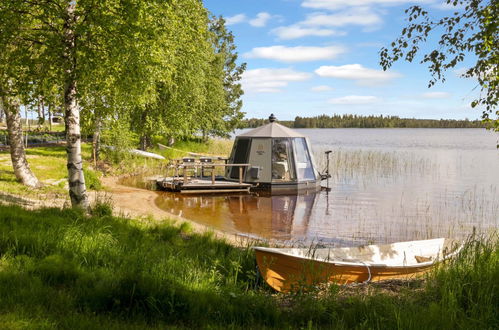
[243,46,346,62]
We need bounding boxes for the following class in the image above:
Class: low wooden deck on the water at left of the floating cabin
[156,177,252,194]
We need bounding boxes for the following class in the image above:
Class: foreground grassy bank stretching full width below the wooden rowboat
[0,205,499,329]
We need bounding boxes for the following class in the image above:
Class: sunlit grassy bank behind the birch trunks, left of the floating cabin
[0,140,232,199]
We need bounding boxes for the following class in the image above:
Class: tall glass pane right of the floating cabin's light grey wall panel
[272,139,296,182]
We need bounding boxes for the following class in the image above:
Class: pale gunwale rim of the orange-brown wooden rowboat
[252,237,463,269]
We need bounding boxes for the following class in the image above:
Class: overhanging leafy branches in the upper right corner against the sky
[380,0,499,131]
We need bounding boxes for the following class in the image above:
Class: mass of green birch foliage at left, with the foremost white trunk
[0,0,248,207]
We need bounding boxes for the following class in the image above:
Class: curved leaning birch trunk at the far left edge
[0,96,41,188]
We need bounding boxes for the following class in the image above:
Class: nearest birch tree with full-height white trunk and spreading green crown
[2,0,200,208]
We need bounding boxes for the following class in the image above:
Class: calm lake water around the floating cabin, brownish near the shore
[156,129,499,246]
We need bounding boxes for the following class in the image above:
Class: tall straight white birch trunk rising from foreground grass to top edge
[64,1,89,209]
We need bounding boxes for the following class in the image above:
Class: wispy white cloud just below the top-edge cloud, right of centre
[300,7,383,27]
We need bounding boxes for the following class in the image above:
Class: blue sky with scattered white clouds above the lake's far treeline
[204,0,481,120]
